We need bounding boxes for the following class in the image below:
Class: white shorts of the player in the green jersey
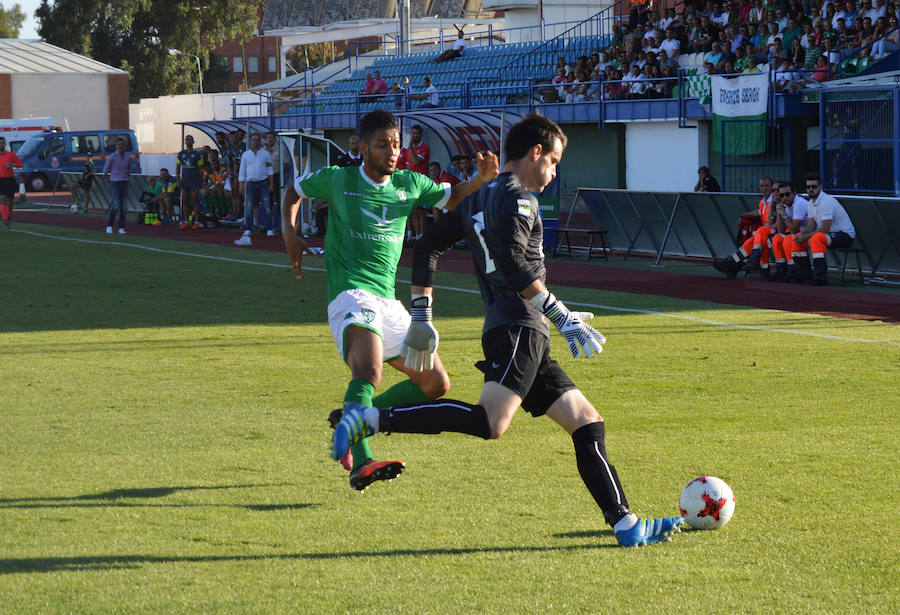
[328,288,410,361]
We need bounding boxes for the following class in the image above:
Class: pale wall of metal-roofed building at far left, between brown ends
[12,74,110,130]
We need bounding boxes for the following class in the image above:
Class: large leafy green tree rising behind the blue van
[35,0,265,101]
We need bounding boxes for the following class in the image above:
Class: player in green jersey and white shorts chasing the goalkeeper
[281,110,499,491]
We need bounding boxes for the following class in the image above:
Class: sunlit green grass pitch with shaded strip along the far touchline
[0,224,900,614]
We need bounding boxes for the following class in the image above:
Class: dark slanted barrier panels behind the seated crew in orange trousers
[566,188,900,275]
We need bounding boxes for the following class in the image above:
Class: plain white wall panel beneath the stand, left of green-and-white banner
[625,122,709,192]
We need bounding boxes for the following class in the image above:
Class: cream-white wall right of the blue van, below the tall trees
[128,92,260,154]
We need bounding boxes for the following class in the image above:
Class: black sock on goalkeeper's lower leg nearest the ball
[572,421,628,526]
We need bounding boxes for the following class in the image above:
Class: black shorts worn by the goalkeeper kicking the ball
[475,325,578,416]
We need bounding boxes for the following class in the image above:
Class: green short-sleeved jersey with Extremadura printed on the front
[294,166,450,301]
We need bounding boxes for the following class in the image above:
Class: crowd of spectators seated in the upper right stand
[540,0,900,102]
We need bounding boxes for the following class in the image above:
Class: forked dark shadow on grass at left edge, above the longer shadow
[0,483,318,512]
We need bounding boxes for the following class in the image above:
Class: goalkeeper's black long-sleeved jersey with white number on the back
[412,173,550,337]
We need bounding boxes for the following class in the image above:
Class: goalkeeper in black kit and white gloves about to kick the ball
[331,113,684,546]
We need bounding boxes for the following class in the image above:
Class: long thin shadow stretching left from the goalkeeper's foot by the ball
[0,543,621,575]
